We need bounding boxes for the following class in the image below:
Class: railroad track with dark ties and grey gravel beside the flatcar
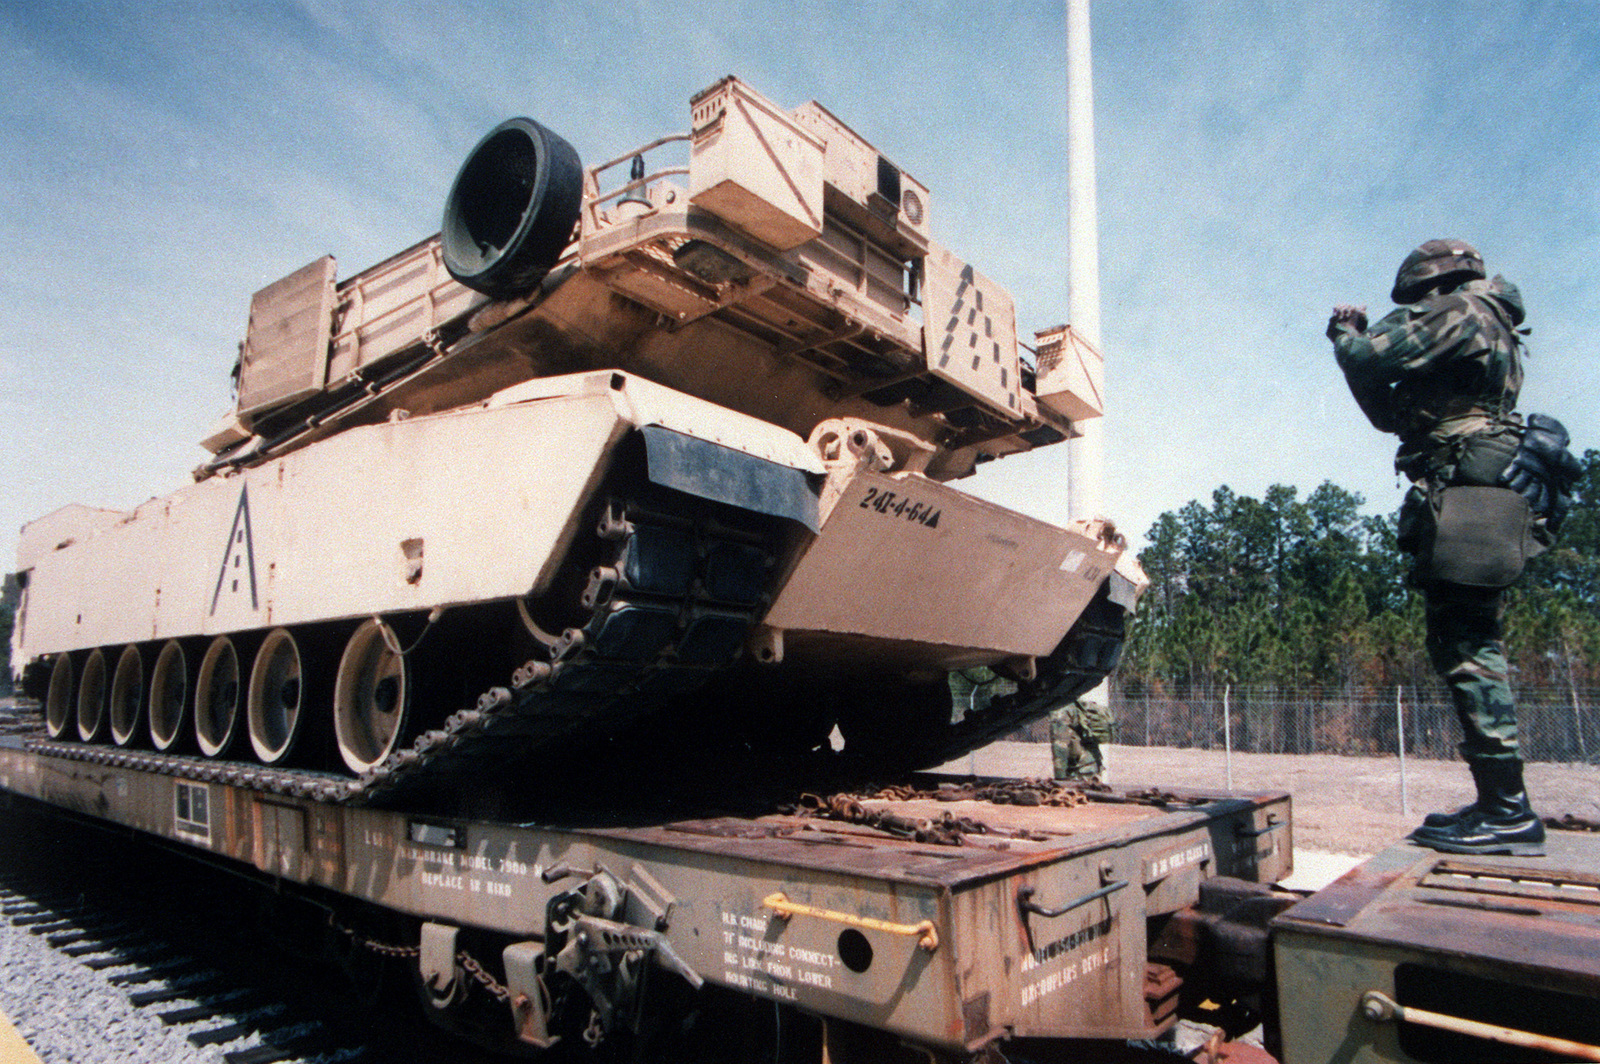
[0,802,486,1064]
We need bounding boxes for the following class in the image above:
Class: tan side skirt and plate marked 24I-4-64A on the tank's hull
[19,374,1120,667]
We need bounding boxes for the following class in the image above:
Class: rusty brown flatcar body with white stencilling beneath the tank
[0,744,1288,1051]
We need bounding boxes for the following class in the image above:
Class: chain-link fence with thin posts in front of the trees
[1110,686,1600,763]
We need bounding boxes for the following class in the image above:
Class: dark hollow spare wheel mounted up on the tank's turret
[440,118,584,299]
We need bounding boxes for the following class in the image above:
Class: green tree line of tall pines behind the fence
[1118,450,1600,694]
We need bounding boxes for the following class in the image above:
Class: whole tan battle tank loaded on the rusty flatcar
[14,78,1142,806]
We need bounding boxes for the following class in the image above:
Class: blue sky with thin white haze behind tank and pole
[0,0,1600,550]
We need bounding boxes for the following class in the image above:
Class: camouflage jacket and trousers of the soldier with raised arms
[1330,277,1523,762]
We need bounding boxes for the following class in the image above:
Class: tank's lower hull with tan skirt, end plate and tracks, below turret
[18,371,1136,773]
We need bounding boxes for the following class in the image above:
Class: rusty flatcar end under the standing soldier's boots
[1272,832,1600,1064]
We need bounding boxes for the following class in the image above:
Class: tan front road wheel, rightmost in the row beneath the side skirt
[333,618,410,776]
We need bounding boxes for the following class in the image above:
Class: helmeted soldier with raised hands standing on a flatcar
[1328,240,1578,854]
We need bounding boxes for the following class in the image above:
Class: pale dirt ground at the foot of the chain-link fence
[949,742,1600,856]
